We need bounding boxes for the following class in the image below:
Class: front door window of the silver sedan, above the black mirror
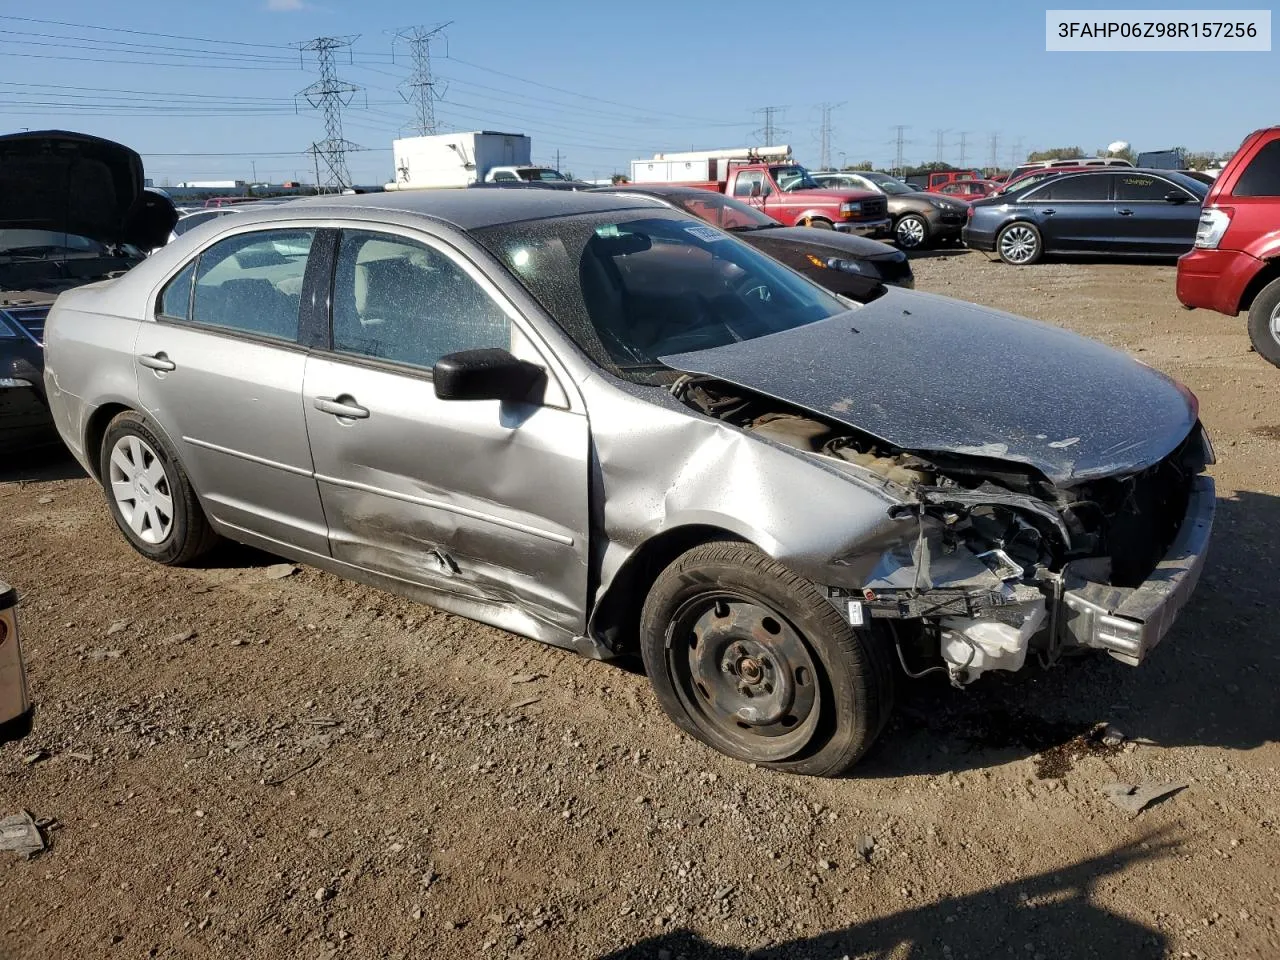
[333,230,511,370]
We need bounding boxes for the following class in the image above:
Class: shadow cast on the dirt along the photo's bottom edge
[596,832,1176,960]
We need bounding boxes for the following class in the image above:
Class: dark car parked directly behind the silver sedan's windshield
[599,184,915,296]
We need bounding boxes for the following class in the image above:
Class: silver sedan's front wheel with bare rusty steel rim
[640,543,893,777]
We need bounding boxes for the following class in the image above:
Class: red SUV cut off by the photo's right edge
[1178,127,1280,366]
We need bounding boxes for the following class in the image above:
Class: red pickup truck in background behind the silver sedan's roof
[632,160,892,238]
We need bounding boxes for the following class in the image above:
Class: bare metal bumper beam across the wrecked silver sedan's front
[1060,476,1215,667]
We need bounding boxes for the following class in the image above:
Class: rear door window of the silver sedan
[191,230,315,340]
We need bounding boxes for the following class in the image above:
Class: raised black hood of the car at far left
[0,131,178,250]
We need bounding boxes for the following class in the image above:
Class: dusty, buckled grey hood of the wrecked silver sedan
[662,289,1197,485]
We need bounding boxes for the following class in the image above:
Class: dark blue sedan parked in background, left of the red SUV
[964,168,1208,266]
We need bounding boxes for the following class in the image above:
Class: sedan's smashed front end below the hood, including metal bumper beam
[828,425,1215,685]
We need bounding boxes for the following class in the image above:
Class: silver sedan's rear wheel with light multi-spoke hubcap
[99,410,218,566]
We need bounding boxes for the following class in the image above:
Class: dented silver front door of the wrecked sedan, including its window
[303,230,589,634]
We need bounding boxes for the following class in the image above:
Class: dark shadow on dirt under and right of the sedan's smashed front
[851,492,1280,778]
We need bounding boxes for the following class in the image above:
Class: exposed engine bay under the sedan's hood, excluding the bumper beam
[671,375,1213,686]
